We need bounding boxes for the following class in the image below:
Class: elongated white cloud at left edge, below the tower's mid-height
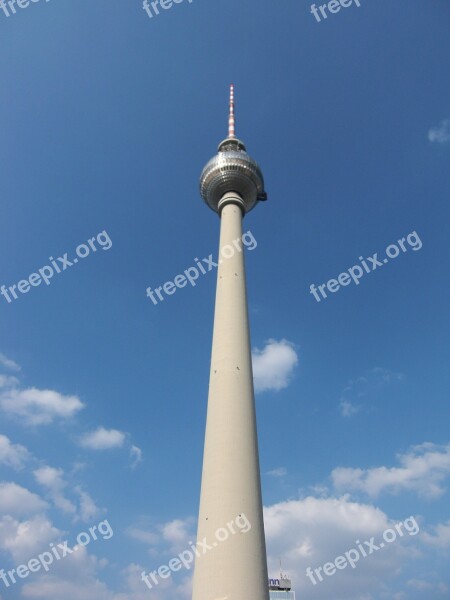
[0,388,84,425]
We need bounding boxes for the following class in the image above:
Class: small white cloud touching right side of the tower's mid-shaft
[252,340,298,392]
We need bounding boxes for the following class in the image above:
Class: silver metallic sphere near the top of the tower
[200,138,267,213]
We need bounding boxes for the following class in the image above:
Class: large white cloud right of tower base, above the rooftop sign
[264,496,417,600]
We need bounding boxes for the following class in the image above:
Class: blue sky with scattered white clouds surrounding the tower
[0,0,450,600]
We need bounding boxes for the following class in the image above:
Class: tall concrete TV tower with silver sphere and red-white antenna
[192,86,269,600]
